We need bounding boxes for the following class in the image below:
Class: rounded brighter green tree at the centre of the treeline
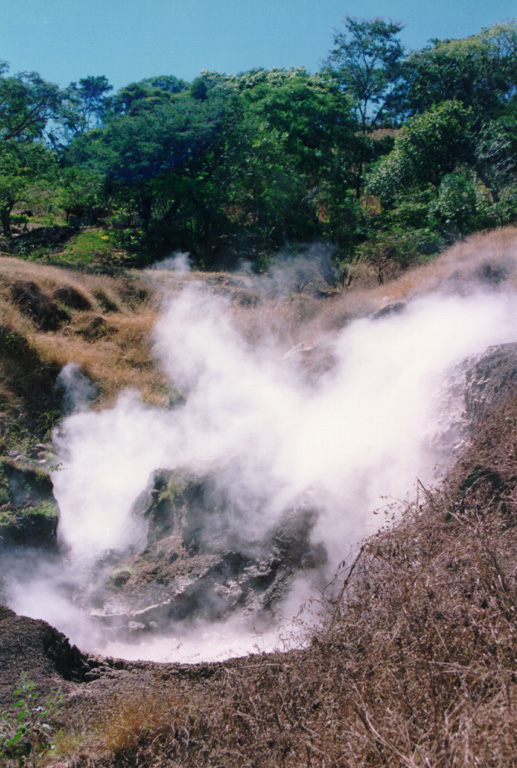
[226,68,356,245]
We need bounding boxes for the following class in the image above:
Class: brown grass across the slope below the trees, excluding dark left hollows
[0,227,517,428]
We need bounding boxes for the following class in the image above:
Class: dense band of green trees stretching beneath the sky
[0,18,517,272]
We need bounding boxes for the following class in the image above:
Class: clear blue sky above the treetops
[0,0,517,89]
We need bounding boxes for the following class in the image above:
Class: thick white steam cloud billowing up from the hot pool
[7,246,517,657]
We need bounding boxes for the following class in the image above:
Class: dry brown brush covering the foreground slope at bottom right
[97,510,517,768]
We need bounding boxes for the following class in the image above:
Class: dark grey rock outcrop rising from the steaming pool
[86,470,326,635]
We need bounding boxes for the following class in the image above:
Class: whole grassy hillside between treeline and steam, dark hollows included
[0,227,516,450]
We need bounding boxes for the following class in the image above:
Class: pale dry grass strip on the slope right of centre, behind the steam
[228,227,517,356]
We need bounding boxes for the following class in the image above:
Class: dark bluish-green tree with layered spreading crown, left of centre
[67,73,236,258]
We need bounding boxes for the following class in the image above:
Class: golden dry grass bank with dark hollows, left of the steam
[0,258,166,448]
